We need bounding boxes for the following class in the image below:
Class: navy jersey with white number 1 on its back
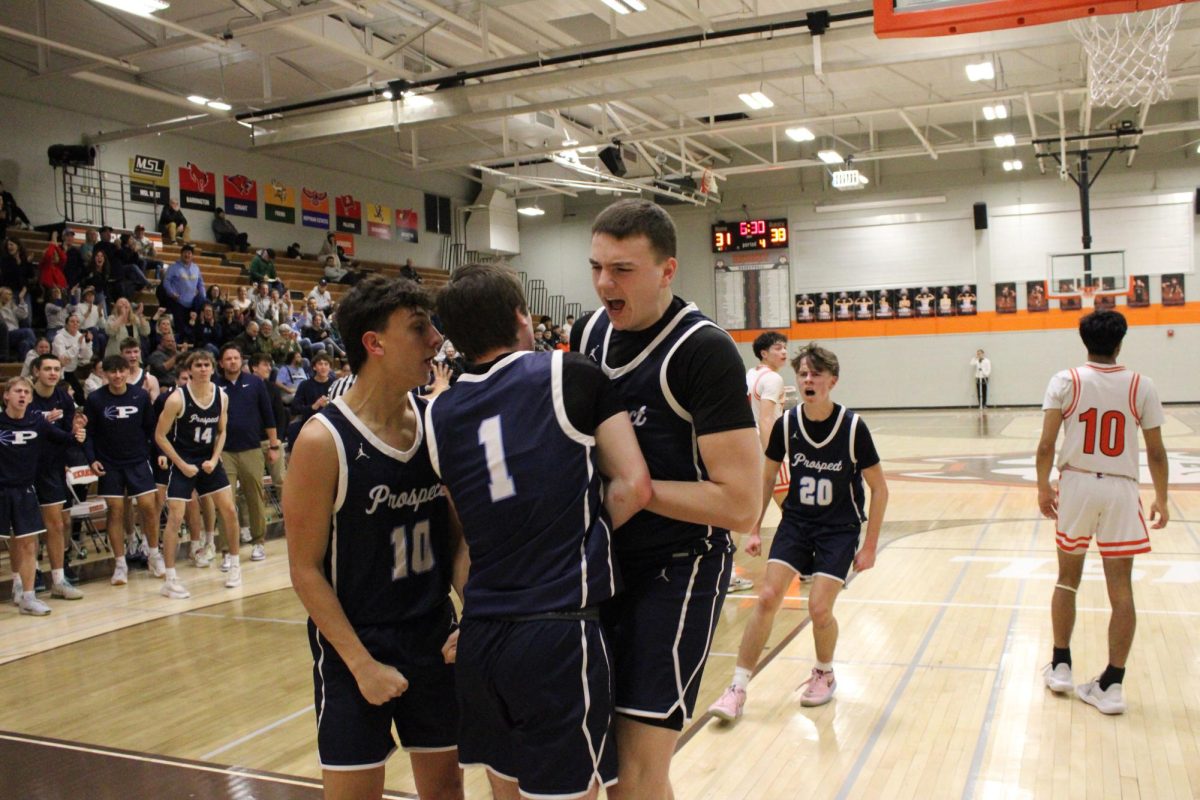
[426,350,616,618]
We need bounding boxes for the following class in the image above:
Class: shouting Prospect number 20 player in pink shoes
[709,344,888,721]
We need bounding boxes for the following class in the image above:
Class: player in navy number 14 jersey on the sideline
[155,350,241,600]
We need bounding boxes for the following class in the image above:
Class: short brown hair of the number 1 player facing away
[434,264,529,366]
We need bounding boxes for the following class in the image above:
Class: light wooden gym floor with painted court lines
[0,407,1200,800]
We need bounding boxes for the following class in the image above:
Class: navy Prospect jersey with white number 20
[776,403,866,528]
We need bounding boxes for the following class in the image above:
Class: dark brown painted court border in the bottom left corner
[0,730,416,800]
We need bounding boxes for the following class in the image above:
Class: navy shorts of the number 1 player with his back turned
[455,616,617,800]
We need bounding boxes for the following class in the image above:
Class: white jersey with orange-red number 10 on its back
[1042,362,1163,481]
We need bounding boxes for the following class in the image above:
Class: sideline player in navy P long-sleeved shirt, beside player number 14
[84,355,167,587]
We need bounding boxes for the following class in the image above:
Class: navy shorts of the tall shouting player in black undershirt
[602,534,733,730]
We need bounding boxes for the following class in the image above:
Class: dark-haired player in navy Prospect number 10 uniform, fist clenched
[283,276,463,800]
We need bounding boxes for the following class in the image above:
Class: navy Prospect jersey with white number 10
[308,396,454,628]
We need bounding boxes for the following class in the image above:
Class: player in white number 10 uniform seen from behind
[1037,309,1168,714]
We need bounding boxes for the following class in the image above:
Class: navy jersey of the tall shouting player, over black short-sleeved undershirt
[576,303,726,553]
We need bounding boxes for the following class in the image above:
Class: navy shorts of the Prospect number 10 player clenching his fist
[308,602,458,771]
